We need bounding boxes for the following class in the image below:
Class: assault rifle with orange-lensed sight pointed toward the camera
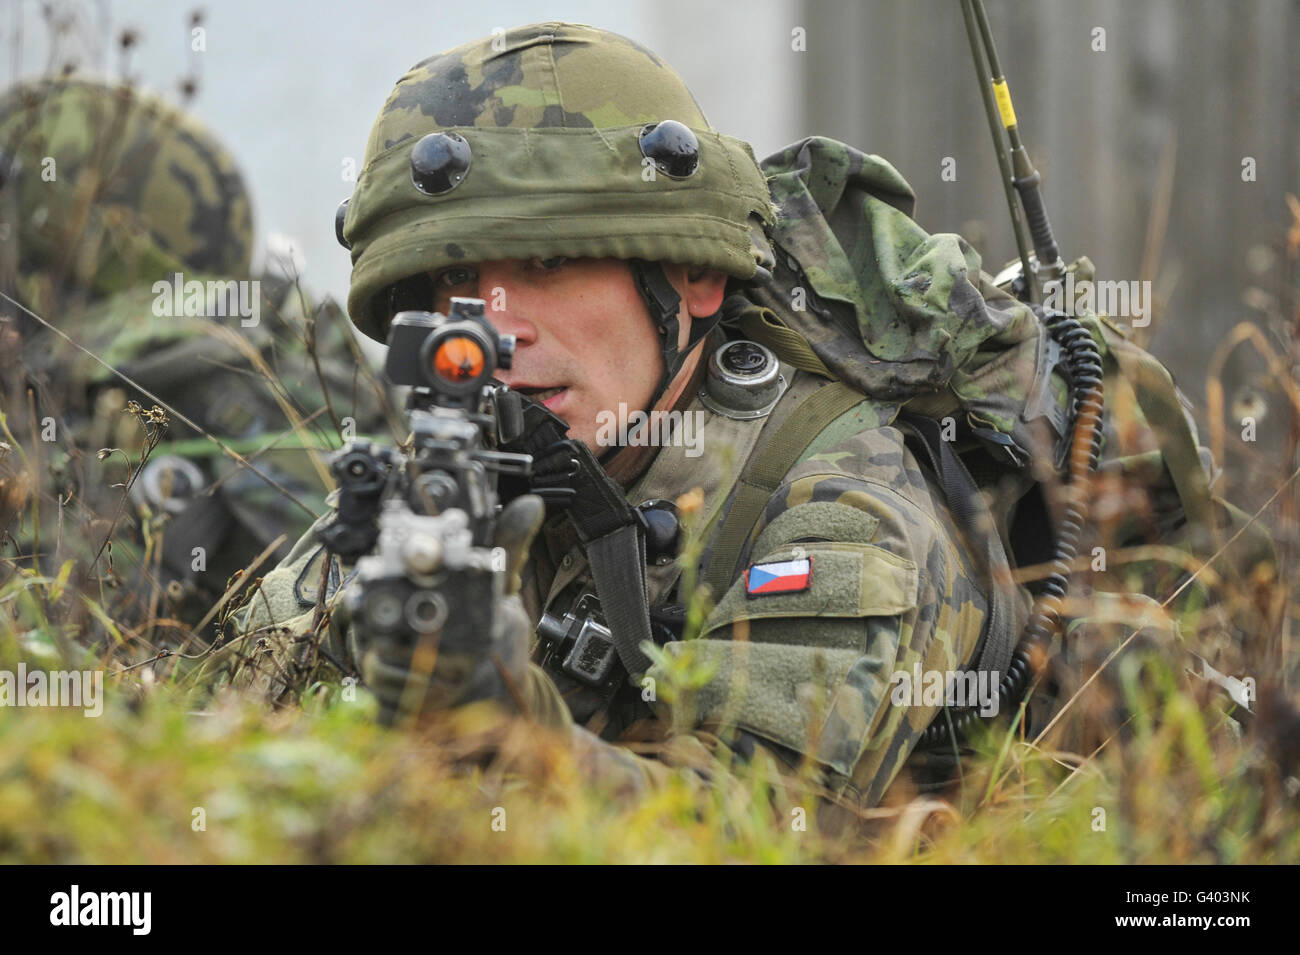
[317,298,533,691]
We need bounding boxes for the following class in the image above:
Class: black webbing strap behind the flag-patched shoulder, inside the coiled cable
[894,414,1015,685]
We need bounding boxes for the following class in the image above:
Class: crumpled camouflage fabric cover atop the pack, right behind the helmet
[745,136,1037,401]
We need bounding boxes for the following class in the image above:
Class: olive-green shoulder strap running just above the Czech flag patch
[705,382,866,598]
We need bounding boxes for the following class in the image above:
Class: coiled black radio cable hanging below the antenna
[917,309,1105,748]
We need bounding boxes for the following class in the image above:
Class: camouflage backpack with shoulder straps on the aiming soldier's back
[707,138,1270,732]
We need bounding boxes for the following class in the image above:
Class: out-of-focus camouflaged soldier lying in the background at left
[0,77,390,624]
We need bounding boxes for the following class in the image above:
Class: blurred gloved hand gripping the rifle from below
[361,494,545,725]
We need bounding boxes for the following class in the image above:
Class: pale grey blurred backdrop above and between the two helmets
[0,0,801,300]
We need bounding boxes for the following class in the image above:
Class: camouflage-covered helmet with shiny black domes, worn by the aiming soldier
[335,23,775,340]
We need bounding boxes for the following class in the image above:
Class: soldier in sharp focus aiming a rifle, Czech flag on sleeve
[210,23,1258,804]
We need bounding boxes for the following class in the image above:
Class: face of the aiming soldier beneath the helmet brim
[434,259,725,453]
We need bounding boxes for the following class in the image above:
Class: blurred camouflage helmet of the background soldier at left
[0,77,252,304]
